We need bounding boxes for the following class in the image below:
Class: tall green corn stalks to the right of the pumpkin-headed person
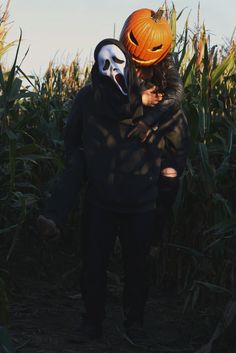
[161,3,236,309]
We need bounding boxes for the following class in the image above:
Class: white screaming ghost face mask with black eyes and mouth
[97,44,127,96]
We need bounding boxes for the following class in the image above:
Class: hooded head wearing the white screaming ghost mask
[91,38,141,119]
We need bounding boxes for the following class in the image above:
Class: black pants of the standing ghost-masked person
[81,202,155,324]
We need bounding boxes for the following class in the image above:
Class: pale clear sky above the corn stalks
[3,0,236,76]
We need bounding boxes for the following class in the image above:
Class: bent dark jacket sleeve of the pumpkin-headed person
[143,55,184,129]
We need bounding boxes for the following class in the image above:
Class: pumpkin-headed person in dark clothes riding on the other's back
[120,7,190,246]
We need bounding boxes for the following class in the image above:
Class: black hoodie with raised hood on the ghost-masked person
[65,39,161,213]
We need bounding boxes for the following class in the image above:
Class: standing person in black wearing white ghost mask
[37,39,161,346]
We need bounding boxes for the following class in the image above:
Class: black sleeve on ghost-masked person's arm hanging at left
[43,90,86,226]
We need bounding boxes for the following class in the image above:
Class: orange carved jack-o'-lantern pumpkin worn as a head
[120,9,172,66]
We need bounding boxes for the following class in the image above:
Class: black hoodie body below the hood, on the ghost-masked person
[65,86,161,213]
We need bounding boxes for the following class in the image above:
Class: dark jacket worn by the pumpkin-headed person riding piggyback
[140,54,190,176]
